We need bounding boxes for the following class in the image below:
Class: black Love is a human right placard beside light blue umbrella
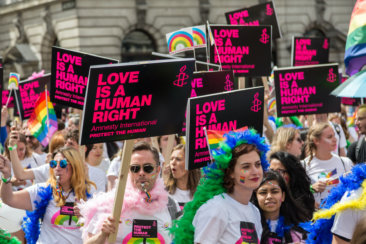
[274,64,341,117]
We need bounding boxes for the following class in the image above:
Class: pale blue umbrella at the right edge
[330,70,366,97]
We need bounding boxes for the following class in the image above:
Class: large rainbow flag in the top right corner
[344,0,366,76]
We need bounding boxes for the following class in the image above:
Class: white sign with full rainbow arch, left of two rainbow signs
[166,27,193,54]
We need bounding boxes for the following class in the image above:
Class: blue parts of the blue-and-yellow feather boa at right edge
[300,164,366,244]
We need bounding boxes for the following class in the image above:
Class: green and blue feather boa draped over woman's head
[170,129,269,244]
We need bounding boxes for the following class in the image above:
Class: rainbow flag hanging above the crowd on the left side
[28,91,57,147]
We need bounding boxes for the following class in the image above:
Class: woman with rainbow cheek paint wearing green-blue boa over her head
[171,130,268,244]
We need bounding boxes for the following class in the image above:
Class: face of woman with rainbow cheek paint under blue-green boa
[231,151,263,191]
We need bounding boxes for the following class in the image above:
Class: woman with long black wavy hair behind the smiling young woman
[269,152,315,220]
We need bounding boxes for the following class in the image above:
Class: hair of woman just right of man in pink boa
[165,144,201,197]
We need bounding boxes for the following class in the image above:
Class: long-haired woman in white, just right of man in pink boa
[165,144,201,209]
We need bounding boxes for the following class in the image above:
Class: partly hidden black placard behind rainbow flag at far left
[13,74,51,120]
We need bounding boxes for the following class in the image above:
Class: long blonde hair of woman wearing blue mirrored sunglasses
[47,147,96,206]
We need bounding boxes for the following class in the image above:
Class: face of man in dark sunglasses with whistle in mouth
[130,150,160,191]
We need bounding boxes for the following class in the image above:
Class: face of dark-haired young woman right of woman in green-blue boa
[256,180,285,216]
